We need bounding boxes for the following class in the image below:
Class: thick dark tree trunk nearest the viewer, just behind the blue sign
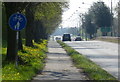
[5,3,17,61]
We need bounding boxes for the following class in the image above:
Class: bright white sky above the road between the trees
[62,0,119,27]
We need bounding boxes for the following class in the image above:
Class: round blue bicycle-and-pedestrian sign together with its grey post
[9,13,27,67]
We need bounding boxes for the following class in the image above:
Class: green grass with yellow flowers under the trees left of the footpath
[2,40,47,80]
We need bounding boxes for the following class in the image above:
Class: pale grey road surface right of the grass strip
[65,41,118,78]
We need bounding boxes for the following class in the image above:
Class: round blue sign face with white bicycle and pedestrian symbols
[9,13,27,31]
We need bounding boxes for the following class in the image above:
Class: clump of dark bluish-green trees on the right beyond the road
[80,1,119,39]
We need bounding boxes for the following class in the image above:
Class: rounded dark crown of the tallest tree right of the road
[89,2,112,27]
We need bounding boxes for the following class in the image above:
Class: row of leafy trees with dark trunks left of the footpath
[2,2,68,61]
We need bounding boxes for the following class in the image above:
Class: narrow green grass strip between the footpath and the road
[58,41,117,80]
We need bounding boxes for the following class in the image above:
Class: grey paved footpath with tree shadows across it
[33,41,88,80]
